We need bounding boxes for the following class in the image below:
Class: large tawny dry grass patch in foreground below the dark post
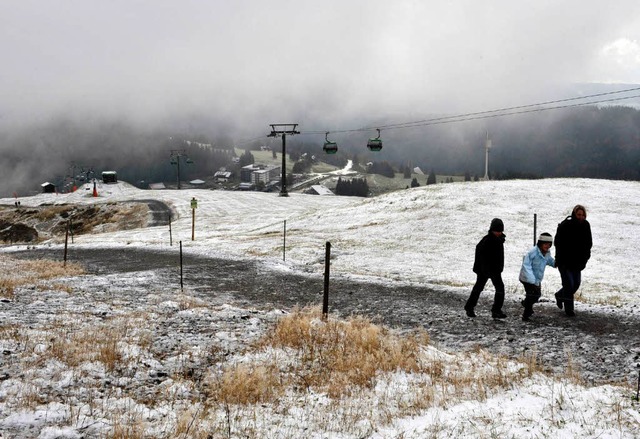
[208,308,429,404]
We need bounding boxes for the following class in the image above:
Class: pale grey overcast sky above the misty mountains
[0,0,640,135]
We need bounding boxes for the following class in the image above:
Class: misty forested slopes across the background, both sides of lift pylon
[0,106,640,196]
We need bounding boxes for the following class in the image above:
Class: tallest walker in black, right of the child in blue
[555,204,593,317]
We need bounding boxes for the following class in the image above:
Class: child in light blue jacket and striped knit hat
[520,233,555,322]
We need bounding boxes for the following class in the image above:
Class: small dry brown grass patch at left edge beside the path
[0,255,84,299]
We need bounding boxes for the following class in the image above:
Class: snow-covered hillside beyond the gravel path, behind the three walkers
[0,179,640,304]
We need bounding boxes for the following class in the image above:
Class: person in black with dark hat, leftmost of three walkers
[464,218,507,319]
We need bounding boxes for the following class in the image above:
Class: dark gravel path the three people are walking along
[14,249,640,388]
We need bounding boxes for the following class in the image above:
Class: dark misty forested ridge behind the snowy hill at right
[294,106,640,181]
